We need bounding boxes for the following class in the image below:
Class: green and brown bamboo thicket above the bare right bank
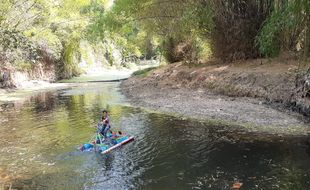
[88,0,310,62]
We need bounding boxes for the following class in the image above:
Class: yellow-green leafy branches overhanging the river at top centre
[85,0,213,61]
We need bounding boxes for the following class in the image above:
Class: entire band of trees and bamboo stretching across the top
[0,0,310,78]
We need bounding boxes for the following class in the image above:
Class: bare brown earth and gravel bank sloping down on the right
[121,60,310,134]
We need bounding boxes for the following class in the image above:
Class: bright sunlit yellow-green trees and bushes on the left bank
[0,0,106,78]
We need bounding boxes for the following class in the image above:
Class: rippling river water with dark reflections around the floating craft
[0,83,310,190]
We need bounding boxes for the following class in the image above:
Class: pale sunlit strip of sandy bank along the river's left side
[0,60,158,104]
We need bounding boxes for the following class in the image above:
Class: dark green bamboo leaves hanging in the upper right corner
[256,0,310,57]
